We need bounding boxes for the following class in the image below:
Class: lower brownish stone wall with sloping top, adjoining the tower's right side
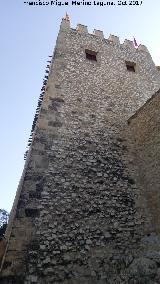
[128,91,160,234]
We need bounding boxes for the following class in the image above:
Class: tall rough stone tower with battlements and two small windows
[0,16,160,284]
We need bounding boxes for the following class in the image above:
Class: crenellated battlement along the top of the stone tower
[61,19,149,53]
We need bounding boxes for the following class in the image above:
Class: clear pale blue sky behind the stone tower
[0,0,160,211]
